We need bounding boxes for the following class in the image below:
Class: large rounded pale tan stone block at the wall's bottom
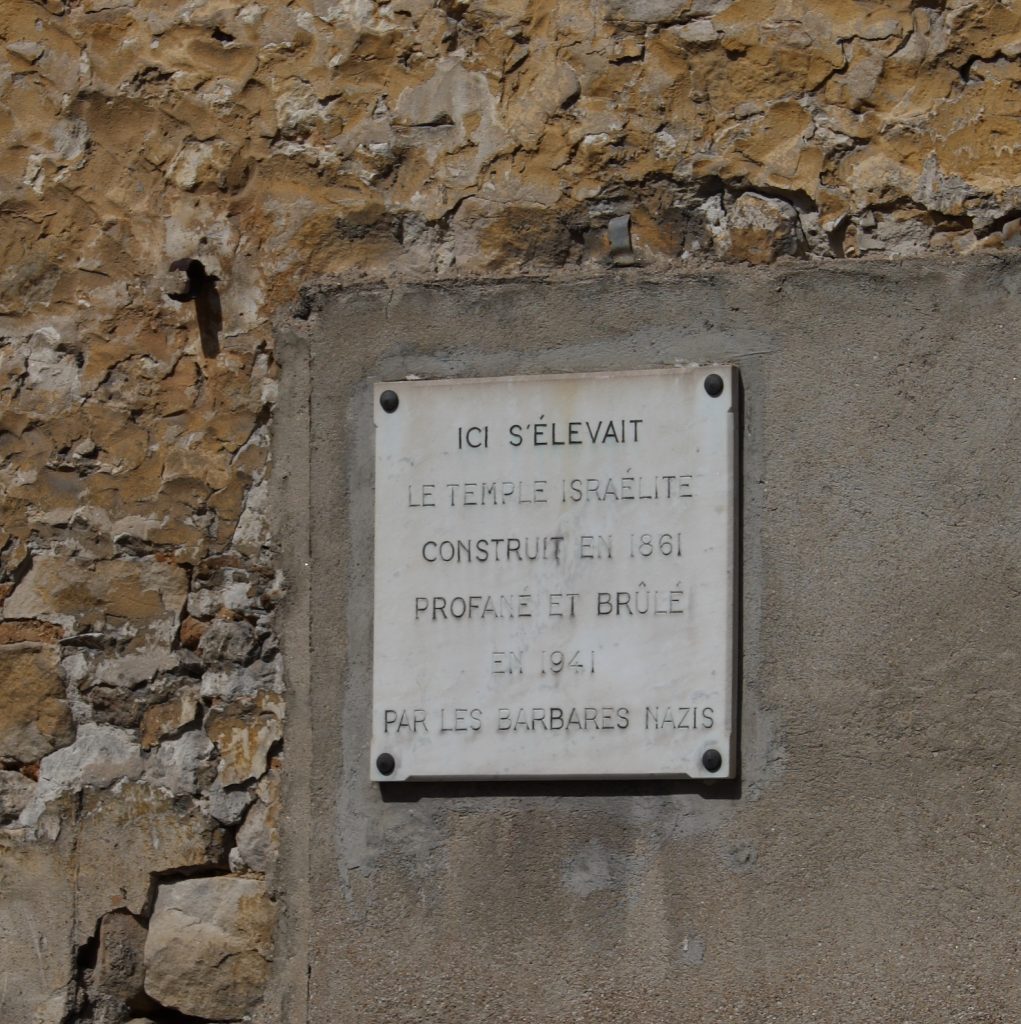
[145,877,274,1021]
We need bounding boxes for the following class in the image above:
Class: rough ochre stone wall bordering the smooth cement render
[0,0,1021,1024]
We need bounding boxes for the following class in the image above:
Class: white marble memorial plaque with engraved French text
[372,366,737,781]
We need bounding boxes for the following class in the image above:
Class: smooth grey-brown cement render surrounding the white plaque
[274,260,1021,1024]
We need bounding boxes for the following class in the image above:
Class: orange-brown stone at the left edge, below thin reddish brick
[0,643,75,762]
